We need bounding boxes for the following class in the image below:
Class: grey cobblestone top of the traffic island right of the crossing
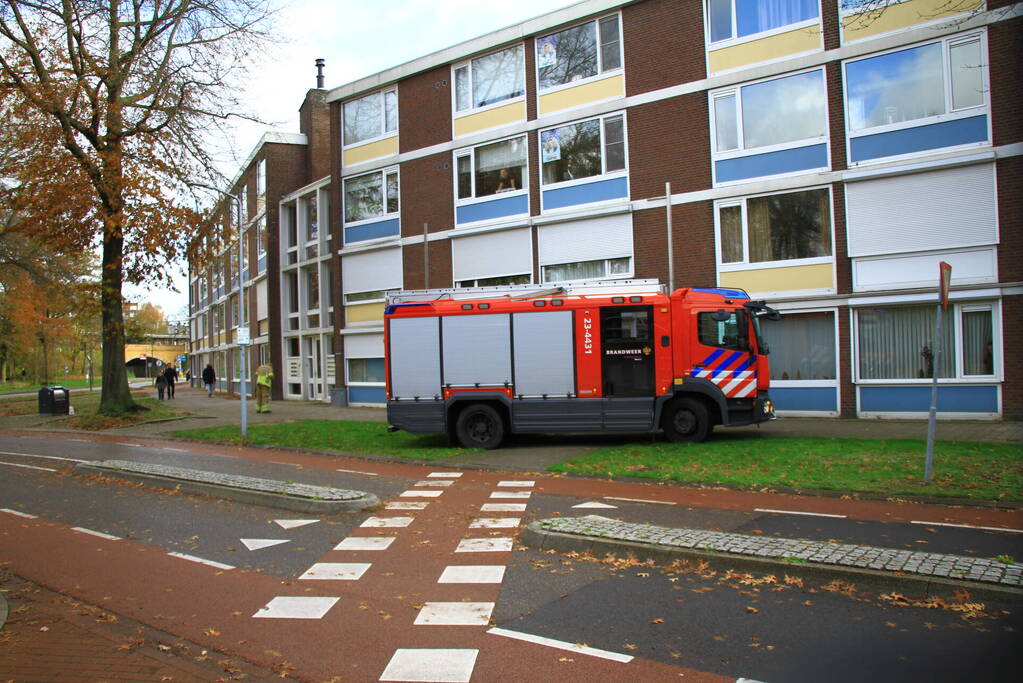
[538,517,1023,587]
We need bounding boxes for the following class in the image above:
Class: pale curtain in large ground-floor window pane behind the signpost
[857,306,955,379]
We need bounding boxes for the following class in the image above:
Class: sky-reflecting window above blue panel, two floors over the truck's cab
[711,70,828,153]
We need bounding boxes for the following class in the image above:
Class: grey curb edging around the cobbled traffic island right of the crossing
[520,517,1023,604]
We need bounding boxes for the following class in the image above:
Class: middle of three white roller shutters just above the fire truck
[451,228,533,282]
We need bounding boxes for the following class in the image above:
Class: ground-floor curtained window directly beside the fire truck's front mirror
[758,311,836,380]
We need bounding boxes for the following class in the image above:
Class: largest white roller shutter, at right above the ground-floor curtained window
[845,164,998,257]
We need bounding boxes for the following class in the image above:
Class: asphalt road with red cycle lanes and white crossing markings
[0,436,1023,683]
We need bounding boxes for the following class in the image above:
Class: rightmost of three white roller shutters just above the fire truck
[538,214,632,266]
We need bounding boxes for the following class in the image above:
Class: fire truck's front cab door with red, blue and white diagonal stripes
[687,308,757,399]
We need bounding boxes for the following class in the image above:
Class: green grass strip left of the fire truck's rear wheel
[172,420,473,460]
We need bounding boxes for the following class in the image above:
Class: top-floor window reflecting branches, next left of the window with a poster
[454,45,526,111]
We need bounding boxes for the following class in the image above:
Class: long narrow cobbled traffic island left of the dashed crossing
[75,460,380,513]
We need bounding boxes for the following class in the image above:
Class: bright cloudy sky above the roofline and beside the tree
[125,0,578,320]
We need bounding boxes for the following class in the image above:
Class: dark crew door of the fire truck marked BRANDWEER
[601,306,654,430]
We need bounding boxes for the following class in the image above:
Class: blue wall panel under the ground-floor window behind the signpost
[859,384,998,413]
